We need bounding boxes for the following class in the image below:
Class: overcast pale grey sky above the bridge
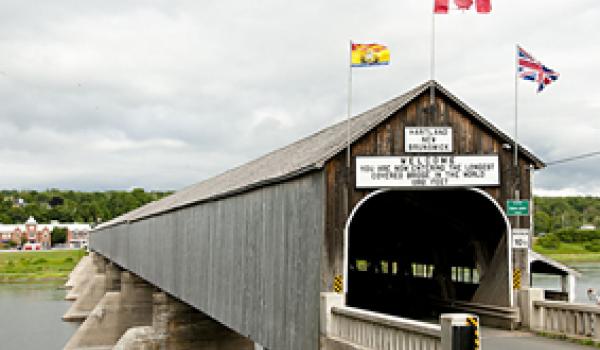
[0,0,600,195]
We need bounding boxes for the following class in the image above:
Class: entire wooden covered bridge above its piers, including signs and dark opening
[90,82,544,350]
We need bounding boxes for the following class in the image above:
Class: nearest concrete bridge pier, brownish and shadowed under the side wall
[114,292,255,350]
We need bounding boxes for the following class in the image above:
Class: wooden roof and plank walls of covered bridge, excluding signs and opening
[90,83,541,350]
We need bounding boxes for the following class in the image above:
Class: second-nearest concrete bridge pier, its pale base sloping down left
[65,265,156,350]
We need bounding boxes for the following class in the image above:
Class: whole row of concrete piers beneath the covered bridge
[63,254,255,350]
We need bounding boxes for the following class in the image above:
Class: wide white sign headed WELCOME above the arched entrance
[356,155,500,188]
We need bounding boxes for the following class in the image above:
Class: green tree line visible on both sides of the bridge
[0,188,600,234]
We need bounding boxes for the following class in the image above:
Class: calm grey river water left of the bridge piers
[0,281,78,350]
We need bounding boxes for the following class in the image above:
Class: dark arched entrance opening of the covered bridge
[346,189,511,319]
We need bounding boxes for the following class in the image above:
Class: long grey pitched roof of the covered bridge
[97,81,545,229]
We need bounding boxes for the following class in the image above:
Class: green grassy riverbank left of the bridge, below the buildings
[0,250,85,283]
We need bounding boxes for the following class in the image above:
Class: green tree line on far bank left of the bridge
[0,188,172,224]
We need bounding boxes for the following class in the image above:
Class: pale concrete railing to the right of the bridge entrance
[531,301,600,341]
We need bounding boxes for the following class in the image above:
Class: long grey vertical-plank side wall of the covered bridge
[90,171,325,350]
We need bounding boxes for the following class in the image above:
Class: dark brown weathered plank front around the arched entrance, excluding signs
[321,92,531,304]
